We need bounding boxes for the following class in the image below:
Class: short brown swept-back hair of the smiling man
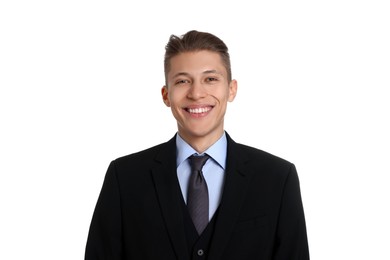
[164,30,232,82]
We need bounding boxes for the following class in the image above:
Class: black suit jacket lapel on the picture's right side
[209,134,252,259]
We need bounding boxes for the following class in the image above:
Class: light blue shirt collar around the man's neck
[176,132,227,169]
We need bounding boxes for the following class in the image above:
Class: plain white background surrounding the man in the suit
[0,0,390,260]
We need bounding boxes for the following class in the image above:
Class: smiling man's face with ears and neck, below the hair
[162,51,237,145]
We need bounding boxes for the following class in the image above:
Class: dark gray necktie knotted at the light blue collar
[187,154,210,235]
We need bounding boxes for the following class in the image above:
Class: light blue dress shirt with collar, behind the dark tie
[176,133,227,220]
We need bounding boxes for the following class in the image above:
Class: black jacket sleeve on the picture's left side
[85,161,122,260]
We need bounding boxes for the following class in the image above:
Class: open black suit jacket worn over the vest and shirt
[85,135,309,260]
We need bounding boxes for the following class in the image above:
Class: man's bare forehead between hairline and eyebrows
[168,50,227,77]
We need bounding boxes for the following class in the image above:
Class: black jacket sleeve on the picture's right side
[273,164,310,260]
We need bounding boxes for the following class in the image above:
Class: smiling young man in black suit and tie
[85,31,309,260]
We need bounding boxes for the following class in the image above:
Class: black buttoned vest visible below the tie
[182,196,219,260]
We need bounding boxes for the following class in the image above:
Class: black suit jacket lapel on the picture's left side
[152,138,189,260]
